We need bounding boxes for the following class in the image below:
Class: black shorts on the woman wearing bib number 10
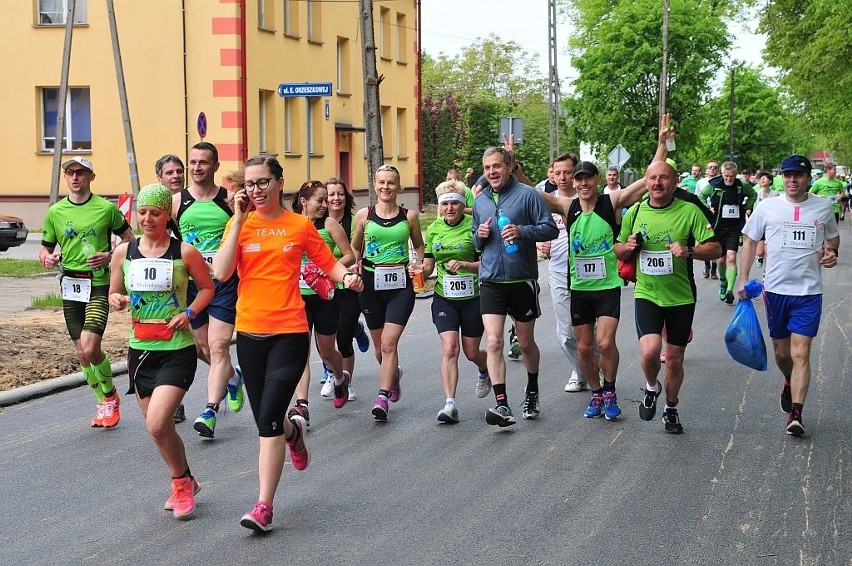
[127,344,198,399]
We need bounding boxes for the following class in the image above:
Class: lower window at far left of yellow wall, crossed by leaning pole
[39,87,92,152]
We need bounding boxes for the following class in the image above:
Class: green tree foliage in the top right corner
[760,0,852,158]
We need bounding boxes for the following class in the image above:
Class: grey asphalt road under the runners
[0,254,852,566]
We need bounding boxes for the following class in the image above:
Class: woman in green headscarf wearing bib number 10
[109,184,213,519]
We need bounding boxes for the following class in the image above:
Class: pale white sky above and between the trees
[421,0,766,85]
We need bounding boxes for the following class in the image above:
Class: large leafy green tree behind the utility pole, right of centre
[568,0,730,172]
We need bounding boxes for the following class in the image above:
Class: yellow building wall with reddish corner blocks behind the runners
[0,0,418,226]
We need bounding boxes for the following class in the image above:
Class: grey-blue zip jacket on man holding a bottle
[472,176,559,281]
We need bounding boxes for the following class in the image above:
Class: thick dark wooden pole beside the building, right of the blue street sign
[358,0,384,205]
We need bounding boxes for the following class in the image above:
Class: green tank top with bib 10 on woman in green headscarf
[122,240,195,351]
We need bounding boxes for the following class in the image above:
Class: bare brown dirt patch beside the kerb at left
[0,309,130,391]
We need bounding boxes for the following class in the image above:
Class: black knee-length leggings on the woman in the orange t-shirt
[237,332,310,437]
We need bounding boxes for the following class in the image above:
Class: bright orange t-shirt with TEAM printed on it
[222,210,337,334]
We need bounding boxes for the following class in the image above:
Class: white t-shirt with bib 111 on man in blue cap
[743,195,838,297]
